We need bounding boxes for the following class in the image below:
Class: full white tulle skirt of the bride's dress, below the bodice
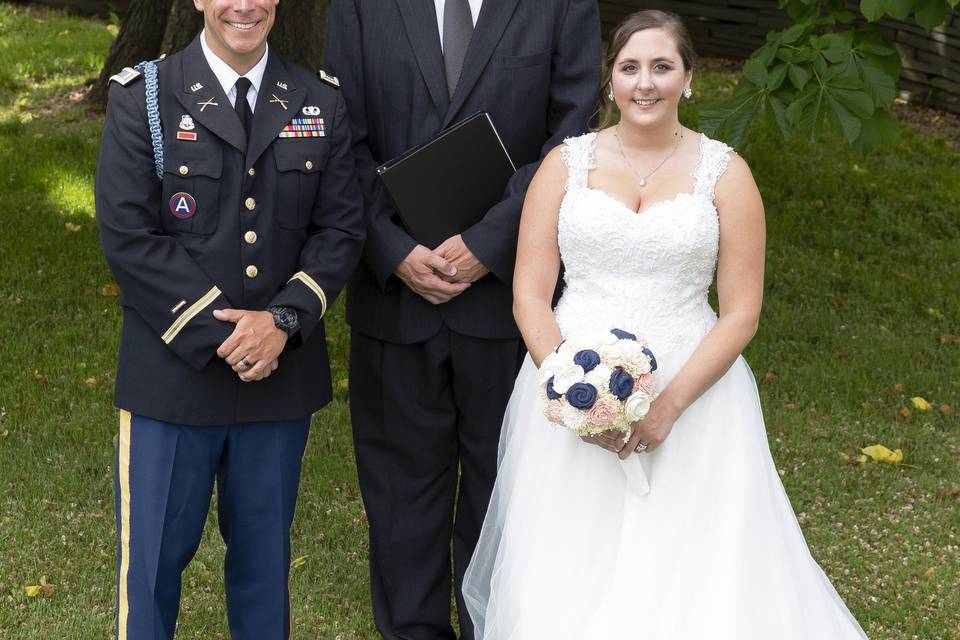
[464,348,866,640]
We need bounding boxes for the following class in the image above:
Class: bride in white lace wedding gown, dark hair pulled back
[463,11,866,640]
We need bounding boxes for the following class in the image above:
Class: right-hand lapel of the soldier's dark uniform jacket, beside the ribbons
[246,52,307,167]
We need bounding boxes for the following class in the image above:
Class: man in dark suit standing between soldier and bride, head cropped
[327,0,600,640]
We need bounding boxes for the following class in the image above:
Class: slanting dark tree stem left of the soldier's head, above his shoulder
[88,0,171,106]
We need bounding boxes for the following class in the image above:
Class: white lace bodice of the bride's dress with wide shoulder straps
[555,133,730,353]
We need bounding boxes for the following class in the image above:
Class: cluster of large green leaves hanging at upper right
[700,0,960,150]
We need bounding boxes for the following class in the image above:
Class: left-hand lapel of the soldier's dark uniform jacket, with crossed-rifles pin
[177,36,247,152]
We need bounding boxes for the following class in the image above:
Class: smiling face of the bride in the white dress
[611,28,693,127]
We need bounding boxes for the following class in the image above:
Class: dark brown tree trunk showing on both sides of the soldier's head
[88,0,330,107]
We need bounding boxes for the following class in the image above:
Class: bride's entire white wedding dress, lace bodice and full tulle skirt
[464,134,866,640]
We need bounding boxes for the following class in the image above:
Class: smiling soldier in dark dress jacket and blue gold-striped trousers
[96,0,364,640]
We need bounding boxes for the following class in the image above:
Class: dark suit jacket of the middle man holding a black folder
[326,0,600,343]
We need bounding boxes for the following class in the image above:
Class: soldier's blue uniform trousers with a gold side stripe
[115,411,310,640]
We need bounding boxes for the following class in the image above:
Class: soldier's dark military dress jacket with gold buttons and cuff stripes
[95,39,364,425]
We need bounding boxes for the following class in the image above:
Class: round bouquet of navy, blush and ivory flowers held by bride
[540,329,657,437]
